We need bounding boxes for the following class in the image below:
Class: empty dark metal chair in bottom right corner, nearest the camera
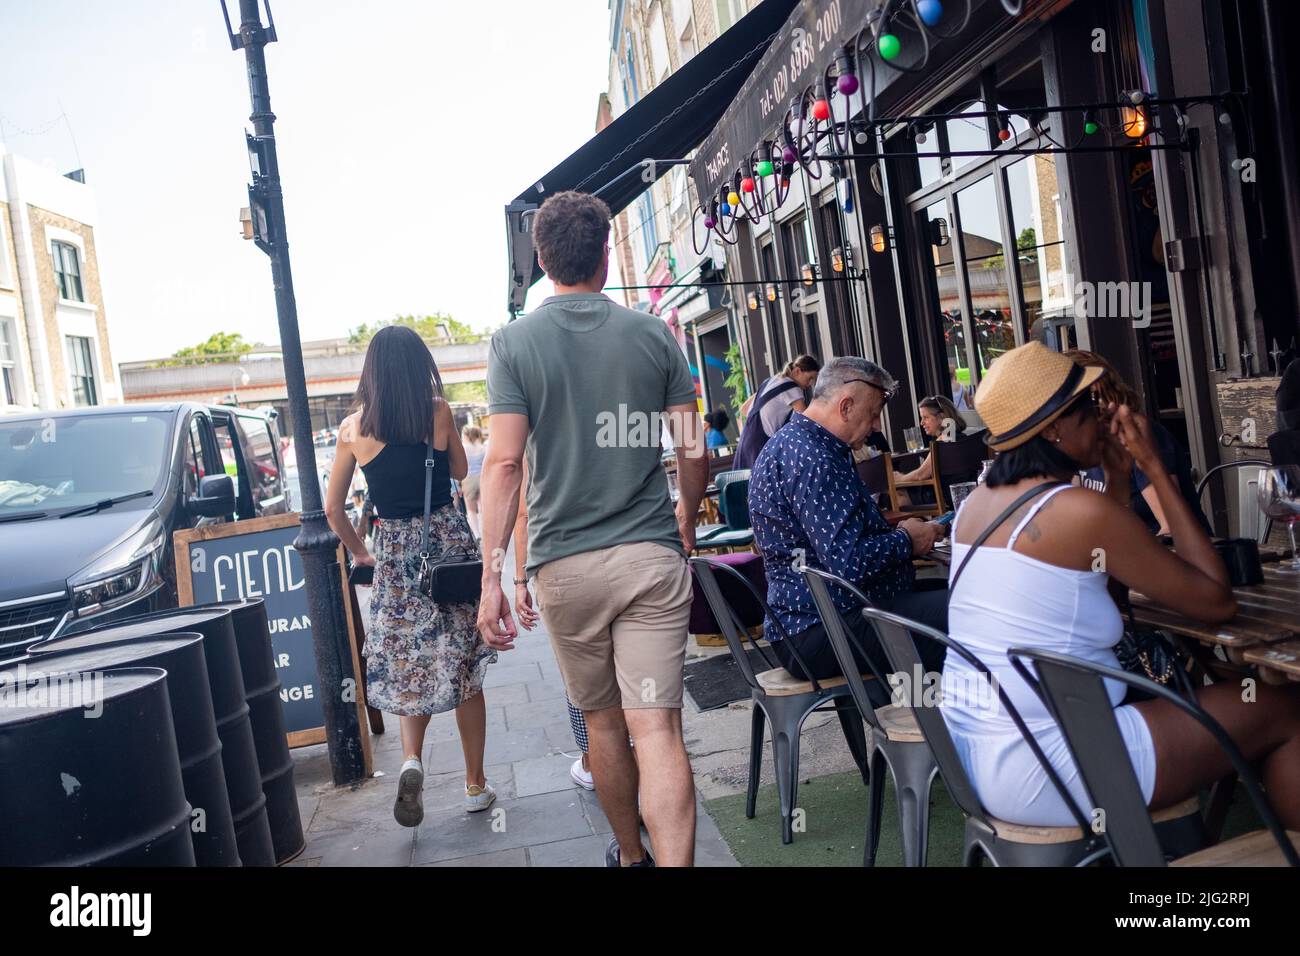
[1008,648,1300,866]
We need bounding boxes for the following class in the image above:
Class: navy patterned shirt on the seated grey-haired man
[749,412,915,641]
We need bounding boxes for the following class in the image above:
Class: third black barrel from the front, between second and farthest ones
[36,607,276,866]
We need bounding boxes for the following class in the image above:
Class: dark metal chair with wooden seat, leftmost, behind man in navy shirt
[690,558,867,843]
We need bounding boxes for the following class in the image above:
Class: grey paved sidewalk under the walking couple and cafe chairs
[291,538,868,866]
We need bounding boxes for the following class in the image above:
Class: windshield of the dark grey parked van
[0,412,172,522]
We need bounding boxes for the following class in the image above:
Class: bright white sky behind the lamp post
[0,0,608,362]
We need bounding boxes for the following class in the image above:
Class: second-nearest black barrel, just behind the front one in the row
[0,634,239,866]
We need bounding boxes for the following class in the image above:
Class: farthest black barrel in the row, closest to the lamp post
[202,597,307,864]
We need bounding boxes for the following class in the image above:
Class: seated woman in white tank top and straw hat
[943,342,1300,830]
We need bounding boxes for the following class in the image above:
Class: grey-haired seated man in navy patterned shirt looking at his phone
[749,358,948,702]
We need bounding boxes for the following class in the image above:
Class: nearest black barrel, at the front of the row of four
[0,666,194,866]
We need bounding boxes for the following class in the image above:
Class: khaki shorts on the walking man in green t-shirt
[537,541,690,710]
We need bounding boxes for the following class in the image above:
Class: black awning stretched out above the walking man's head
[506,0,798,315]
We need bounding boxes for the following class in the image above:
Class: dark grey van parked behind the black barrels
[0,402,289,659]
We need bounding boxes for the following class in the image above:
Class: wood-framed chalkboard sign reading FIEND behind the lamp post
[174,514,369,749]
